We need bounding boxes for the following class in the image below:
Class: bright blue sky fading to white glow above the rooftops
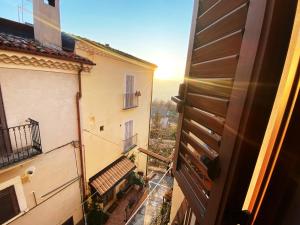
[0,0,193,80]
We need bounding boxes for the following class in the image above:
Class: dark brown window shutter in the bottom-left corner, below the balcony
[0,186,20,224]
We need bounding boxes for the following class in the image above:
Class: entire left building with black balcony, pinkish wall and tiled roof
[0,0,93,225]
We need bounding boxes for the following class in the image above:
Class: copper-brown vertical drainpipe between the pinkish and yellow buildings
[76,64,86,199]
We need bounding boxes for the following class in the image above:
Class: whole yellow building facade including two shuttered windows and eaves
[75,37,156,211]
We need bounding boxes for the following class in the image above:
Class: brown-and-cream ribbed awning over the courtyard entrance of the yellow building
[89,156,136,195]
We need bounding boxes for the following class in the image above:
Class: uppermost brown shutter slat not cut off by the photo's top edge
[194,4,248,48]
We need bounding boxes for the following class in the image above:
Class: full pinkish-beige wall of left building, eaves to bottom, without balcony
[0,65,82,225]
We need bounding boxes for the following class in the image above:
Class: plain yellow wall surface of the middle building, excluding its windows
[77,44,153,179]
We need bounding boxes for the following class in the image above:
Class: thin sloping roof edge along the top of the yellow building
[72,35,157,68]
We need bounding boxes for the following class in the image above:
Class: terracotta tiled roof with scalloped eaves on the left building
[0,33,95,65]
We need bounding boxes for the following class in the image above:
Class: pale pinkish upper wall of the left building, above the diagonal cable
[0,68,78,152]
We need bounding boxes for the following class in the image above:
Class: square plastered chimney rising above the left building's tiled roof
[32,0,62,49]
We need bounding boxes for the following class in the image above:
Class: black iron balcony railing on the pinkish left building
[0,119,42,168]
